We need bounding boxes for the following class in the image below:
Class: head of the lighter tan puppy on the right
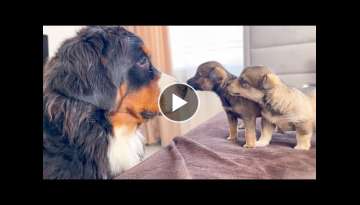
[228,66,279,103]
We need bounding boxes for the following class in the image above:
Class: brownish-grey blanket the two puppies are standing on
[116,113,316,179]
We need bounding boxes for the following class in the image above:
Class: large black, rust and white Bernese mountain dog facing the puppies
[43,26,161,179]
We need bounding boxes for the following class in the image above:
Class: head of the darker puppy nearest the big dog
[187,61,230,91]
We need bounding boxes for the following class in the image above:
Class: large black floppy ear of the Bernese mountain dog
[50,34,117,110]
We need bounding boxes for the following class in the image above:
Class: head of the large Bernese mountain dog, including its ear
[44,26,161,128]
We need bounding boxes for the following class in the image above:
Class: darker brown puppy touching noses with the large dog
[187,61,268,148]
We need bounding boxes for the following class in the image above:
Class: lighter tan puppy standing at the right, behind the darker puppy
[228,66,316,150]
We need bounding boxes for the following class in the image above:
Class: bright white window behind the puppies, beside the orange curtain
[169,26,244,82]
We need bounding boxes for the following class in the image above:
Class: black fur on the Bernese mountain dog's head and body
[43,26,158,179]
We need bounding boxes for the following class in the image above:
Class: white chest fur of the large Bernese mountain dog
[108,125,145,176]
